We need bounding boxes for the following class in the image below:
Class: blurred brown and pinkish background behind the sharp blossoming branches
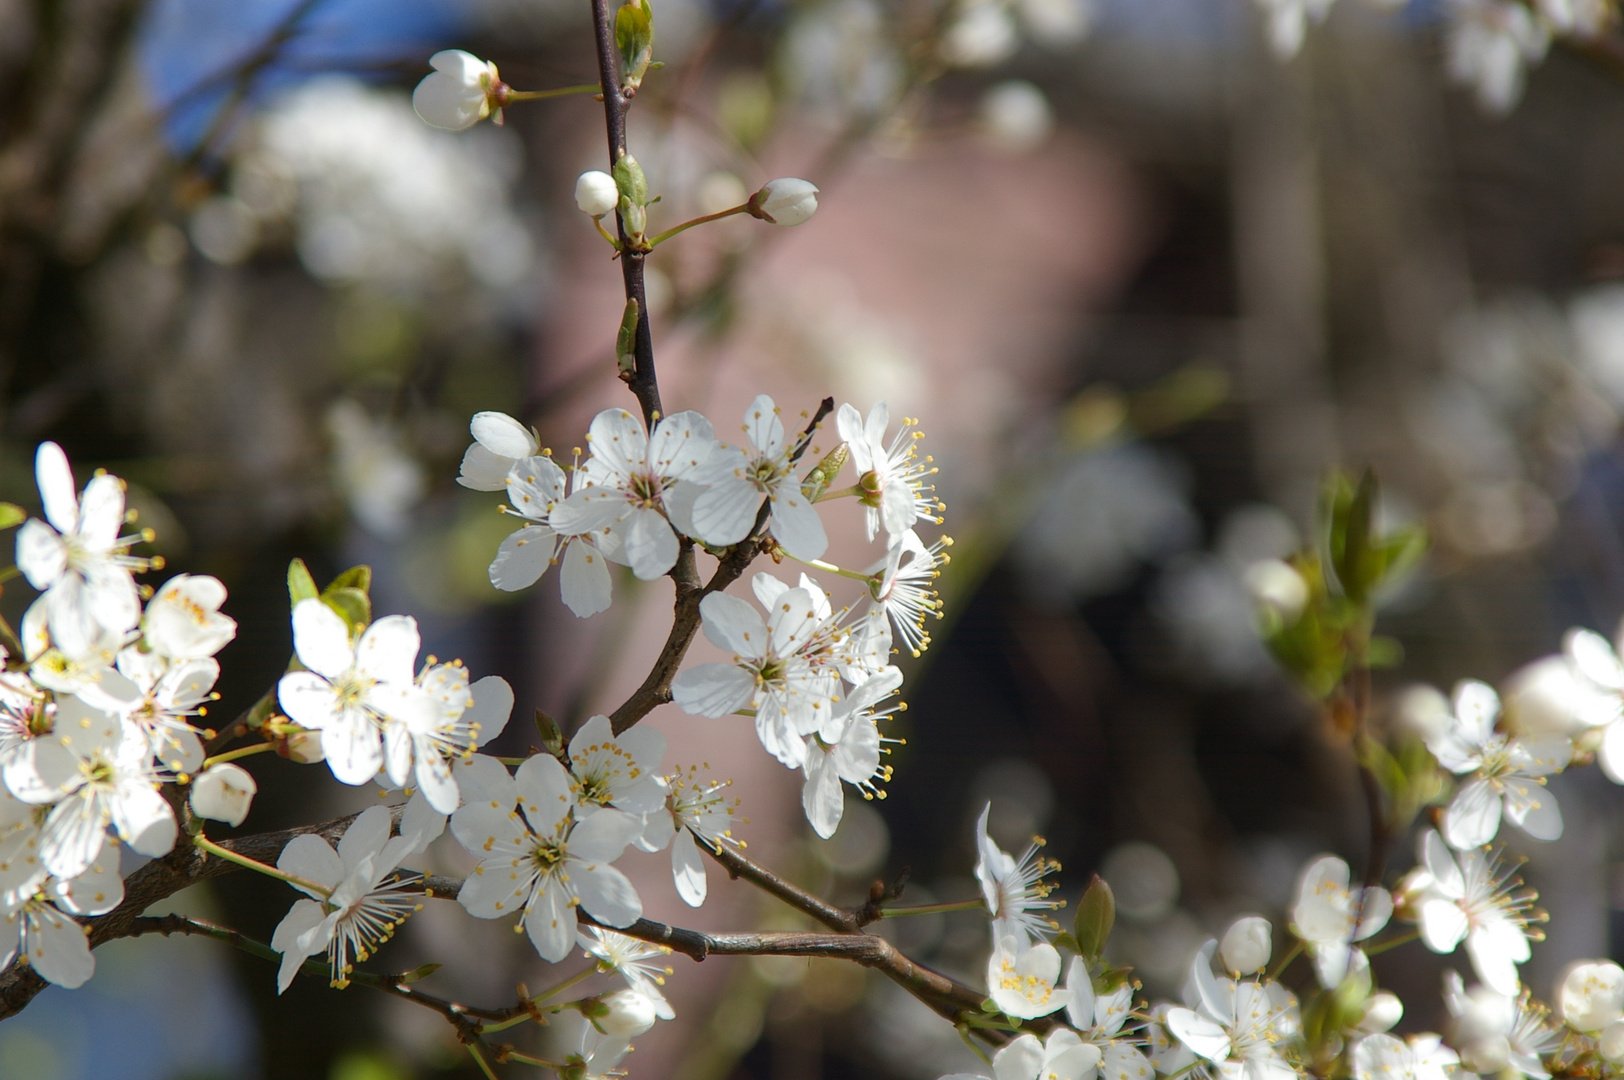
[0,0,1624,1080]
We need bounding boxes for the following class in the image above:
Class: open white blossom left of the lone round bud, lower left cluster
[3,697,177,879]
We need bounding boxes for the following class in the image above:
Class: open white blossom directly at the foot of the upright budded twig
[549,409,716,581]
